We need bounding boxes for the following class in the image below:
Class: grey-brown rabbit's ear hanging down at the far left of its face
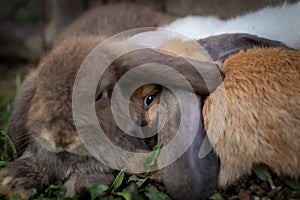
[9,71,36,156]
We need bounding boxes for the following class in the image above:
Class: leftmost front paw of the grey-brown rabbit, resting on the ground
[0,169,36,199]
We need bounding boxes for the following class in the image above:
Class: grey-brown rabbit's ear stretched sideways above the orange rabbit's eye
[112,48,223,96]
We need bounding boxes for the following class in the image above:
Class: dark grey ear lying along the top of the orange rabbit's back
[198,33,288,62]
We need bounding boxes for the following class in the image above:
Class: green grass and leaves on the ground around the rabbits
[0,76,300,200]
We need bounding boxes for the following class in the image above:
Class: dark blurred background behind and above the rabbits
[0,0,297,100]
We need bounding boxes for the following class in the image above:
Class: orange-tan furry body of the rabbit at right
[203,48,300,186]
